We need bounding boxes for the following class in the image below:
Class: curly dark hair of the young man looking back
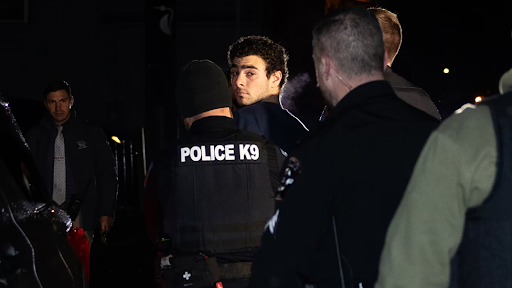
[228,36,288,89]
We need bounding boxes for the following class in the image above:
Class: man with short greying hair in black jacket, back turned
[251,7,438,288]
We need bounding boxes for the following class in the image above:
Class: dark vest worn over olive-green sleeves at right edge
[450,93,512,288]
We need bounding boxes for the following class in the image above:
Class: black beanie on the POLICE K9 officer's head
[176,60,232,118]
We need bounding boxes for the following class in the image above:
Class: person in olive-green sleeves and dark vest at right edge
[375,70,512,288]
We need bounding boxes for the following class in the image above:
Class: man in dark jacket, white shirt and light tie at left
[27,80,117,242]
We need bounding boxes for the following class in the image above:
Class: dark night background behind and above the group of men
[0,0,512,287]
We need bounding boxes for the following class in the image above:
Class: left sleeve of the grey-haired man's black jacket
[250,154,335,287]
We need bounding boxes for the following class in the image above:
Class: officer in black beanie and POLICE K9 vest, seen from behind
[146,60,284,288]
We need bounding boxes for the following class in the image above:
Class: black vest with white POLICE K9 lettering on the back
[164,131,277,254]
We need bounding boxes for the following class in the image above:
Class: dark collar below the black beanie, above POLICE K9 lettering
[189,116,238,138]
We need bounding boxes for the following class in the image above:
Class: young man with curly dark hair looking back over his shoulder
[228,36,307,152]
